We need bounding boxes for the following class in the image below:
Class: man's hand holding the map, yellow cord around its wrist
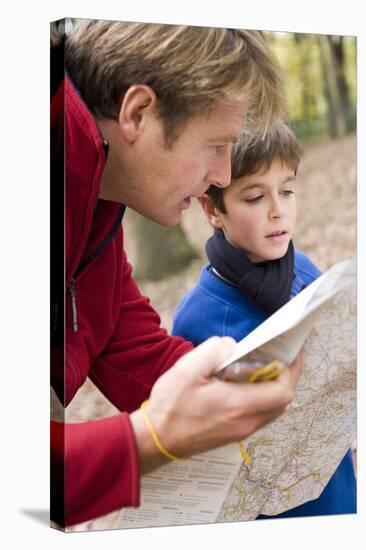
[131,337,303,473]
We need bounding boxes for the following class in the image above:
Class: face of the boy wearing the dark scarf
[210,159,296,262]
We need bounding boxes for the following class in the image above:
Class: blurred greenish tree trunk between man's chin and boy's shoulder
[130,212,199,281]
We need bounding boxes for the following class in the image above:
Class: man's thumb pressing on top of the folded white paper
[177,336,236,377]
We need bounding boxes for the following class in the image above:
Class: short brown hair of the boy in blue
[206,120,301,214]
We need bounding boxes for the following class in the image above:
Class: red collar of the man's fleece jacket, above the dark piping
[64,76,120,287]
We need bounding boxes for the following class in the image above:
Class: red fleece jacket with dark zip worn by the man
[51,78,192,525]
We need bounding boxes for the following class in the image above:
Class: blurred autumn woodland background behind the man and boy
[59,24,357,530]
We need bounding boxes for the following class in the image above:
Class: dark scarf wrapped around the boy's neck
[206,230,294,314]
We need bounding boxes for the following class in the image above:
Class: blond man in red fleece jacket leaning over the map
[51,21,300,525]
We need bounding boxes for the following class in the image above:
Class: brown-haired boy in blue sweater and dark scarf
[173,121,356,518]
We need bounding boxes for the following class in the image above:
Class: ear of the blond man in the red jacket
[118,84,157,143]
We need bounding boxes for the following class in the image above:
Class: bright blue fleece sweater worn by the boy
[172,251,356,519]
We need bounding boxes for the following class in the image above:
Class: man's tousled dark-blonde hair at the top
[65,20,285,141]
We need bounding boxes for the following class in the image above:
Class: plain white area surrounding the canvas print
[0,0,366,550]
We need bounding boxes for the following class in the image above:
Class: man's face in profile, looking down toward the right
[111,103,247,226]
